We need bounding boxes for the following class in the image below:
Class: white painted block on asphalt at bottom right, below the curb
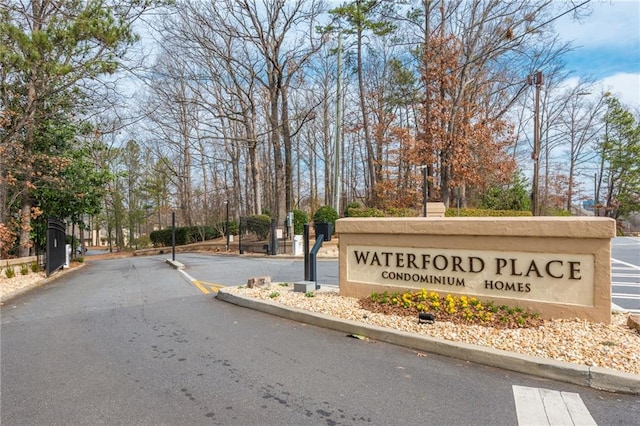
[513,385,596,426]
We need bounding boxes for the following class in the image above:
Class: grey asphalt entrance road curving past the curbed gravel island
[0,255,640,426]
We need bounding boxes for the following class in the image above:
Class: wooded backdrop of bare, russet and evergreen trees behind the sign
[0,0,640,258]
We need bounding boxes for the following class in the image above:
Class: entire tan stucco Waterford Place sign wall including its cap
[336,217,615,323]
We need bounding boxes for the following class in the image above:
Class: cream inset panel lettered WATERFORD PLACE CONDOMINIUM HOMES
[347,245,594,306]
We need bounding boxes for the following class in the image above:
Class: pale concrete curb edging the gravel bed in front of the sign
[216,288,640,395]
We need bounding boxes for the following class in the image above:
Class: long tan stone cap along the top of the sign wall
[336,216,616,238]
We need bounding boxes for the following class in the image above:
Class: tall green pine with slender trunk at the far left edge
[0,0,158,256]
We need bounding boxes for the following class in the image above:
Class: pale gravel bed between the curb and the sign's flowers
[226,283,640,374]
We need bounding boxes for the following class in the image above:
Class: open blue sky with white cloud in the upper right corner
[556,0,640,111]
